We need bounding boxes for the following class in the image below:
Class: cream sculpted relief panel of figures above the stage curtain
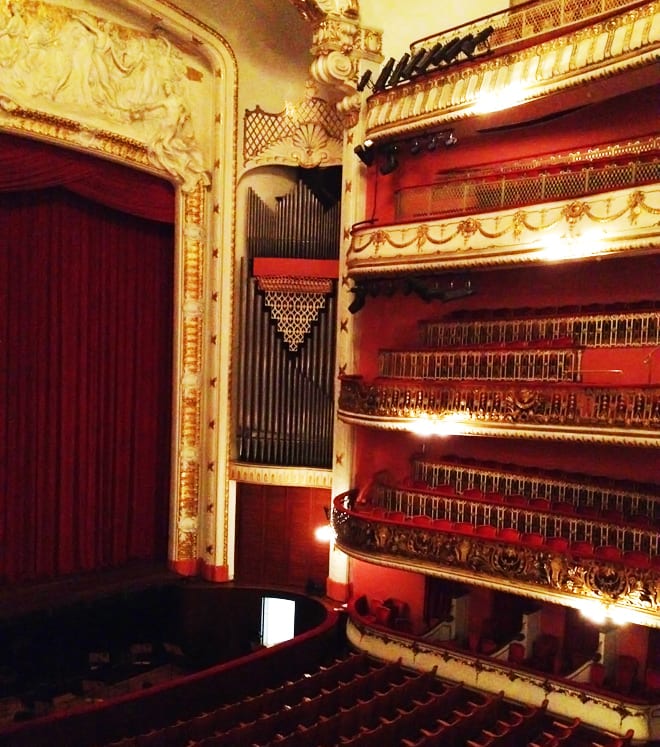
[0,0,209,191]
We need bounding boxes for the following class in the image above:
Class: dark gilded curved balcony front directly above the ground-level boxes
[332,512,660,627]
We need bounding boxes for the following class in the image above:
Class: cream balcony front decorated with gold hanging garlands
[346,186,660,277]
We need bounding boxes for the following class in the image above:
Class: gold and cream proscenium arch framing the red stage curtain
[0,0,238,580]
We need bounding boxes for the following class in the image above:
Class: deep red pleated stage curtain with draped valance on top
[0,138,174,583]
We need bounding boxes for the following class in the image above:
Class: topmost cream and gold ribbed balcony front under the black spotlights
[366,2,660,140]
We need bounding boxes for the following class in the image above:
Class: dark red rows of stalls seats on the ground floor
[107,654,632,747]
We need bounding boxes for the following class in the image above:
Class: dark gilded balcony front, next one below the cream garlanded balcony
[338,376,660,446]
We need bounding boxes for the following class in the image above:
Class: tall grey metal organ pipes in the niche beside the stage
[236,181,340,468]
